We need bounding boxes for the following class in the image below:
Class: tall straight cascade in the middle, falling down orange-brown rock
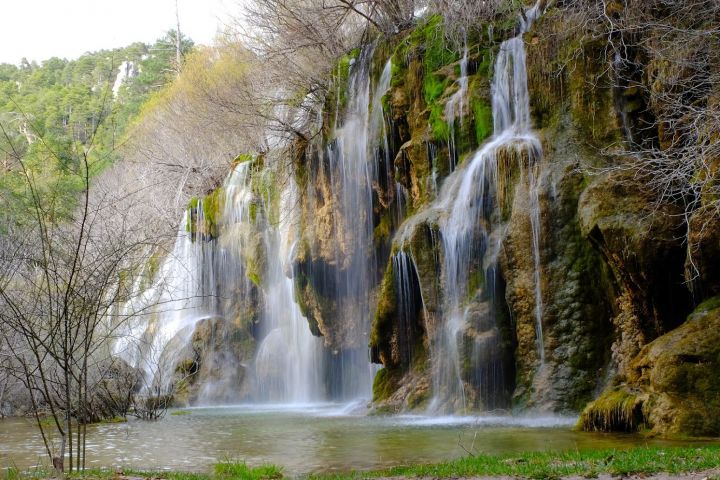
[318,46,390,399]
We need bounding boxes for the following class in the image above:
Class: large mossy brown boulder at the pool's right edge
[580,297,720,437]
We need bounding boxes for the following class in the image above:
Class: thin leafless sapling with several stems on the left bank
[0,80,179,472]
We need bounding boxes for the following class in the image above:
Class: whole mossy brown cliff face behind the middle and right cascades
[139,2,720,435]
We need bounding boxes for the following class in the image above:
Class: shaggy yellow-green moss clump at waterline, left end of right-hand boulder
[577,387,645,432]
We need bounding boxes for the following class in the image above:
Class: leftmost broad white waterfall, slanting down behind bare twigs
[113,162,252,394]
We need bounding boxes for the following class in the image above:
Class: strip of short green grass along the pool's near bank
[5,445,720,480]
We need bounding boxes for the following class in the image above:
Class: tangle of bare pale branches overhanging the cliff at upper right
[554,0,720,284]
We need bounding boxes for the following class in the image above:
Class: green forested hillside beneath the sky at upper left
[0,32,192,229]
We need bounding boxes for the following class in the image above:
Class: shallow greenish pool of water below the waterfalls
[0,405,708,475]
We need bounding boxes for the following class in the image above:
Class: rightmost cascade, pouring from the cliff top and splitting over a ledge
[436,0,544,408]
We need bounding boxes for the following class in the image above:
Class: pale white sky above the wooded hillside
[0,0,238,64]
